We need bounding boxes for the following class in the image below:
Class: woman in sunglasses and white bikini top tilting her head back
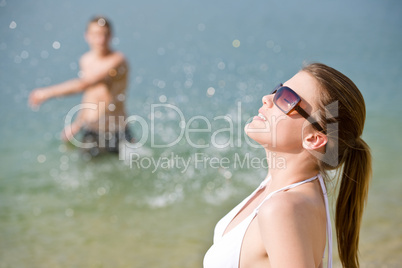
[204,63,371,268]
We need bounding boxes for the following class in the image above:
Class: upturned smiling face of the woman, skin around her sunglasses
[245,71,319,153]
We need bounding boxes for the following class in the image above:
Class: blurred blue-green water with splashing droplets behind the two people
[0,0,402,267]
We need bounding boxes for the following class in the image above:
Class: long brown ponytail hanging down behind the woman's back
[335,138,372,268]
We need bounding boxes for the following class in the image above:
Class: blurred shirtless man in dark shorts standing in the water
[29,17,132,154]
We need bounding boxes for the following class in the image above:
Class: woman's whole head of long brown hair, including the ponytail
[302,63,372,267]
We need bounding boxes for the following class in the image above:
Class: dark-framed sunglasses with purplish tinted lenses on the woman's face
[271,84,324,132]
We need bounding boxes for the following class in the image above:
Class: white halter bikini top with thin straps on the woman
[204,174,332,268]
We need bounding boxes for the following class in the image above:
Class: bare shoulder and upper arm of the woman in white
[256,183,326,267]
